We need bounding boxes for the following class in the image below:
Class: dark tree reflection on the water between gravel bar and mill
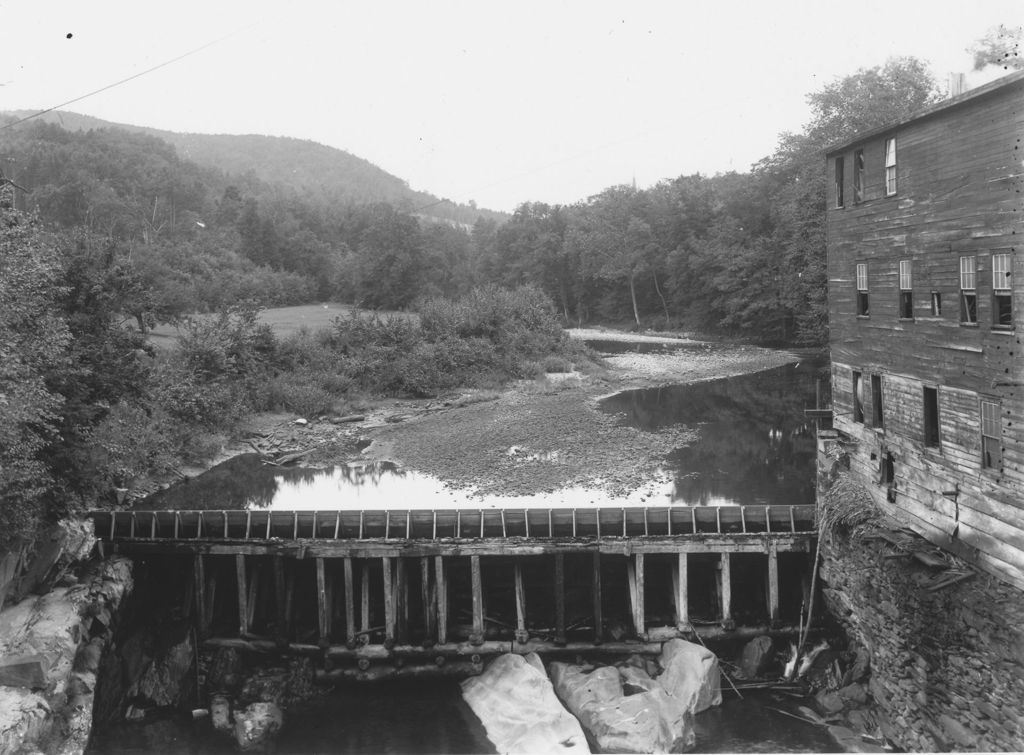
[601,360,826,505]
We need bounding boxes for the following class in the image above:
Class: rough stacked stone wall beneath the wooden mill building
[820,533,1024,752]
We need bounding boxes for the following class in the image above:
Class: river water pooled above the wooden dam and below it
[97,347,839,754]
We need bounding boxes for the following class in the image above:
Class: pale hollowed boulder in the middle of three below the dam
[551,663,695,753]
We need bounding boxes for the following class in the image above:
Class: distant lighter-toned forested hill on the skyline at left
[0,111,508,226]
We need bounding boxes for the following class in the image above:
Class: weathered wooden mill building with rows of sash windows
[826,72,1024,587]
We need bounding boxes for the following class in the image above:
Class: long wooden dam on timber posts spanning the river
[89,505,816,678]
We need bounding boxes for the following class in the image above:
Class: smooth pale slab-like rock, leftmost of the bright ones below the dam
[462,653,590,753]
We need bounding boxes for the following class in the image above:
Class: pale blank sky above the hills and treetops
[0,0,1024,211]
